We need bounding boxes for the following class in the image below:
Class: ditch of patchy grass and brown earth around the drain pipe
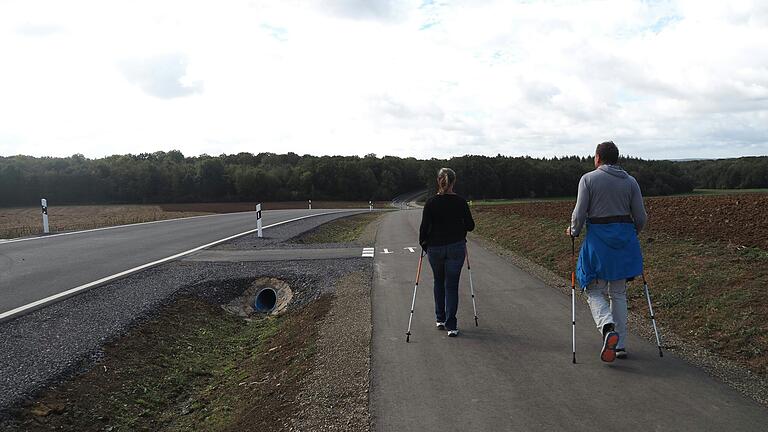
[4,296,331,431]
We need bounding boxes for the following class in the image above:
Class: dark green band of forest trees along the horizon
[0,150,768,207]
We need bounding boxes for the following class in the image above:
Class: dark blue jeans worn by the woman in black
[427,240,467,330]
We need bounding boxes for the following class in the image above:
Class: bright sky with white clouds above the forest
[0,0,768,159]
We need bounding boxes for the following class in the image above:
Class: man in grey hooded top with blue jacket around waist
[566,141,648,362]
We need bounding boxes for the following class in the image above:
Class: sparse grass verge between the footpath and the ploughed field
[473,205,768,377]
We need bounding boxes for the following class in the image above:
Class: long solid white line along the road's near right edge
[0,210,347,322]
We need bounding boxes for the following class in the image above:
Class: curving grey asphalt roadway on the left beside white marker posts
[0,210,360,316]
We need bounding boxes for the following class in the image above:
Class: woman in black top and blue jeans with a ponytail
[419,168,475,337]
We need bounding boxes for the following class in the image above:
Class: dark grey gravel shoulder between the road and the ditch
[0,212,371,414]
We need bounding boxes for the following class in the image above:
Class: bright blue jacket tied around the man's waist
[576,223,643,290]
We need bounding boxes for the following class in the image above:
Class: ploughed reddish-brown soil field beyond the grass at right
[474,193,768,251]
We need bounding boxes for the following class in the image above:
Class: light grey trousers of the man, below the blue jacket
[586,279,627,348]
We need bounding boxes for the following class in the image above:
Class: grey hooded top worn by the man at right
[571,165,648,236]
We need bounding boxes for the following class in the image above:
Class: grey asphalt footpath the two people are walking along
[371,210,768,432]
